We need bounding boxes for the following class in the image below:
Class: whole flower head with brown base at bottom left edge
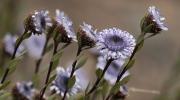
[12,82,35,100]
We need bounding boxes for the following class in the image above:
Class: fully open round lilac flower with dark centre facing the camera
[97,28,136,59]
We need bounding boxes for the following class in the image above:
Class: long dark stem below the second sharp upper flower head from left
[40,43,58,100]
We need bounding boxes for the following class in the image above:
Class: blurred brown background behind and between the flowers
[0,0,180,100]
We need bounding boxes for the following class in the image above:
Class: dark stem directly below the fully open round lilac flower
[88,59,113,94]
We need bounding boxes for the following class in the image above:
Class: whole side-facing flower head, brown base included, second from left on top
[54,10,76,43]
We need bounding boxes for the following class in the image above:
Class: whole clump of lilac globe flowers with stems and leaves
[0,6,168,100]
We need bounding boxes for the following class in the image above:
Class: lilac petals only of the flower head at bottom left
[14,82,36,100]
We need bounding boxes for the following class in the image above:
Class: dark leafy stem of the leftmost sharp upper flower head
[1,31,27,84]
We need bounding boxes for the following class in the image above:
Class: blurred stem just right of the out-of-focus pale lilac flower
[35,36,50,74]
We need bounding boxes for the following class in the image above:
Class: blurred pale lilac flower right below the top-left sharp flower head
[25,34,46,59]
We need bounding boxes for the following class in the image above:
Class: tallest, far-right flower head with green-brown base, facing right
[141,6,168,34]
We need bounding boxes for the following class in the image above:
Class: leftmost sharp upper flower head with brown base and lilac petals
[25,10,52,34]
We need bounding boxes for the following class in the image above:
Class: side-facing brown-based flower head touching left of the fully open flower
[77,22,96,47]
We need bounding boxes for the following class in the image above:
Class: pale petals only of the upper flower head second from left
[55,9,76,40]
